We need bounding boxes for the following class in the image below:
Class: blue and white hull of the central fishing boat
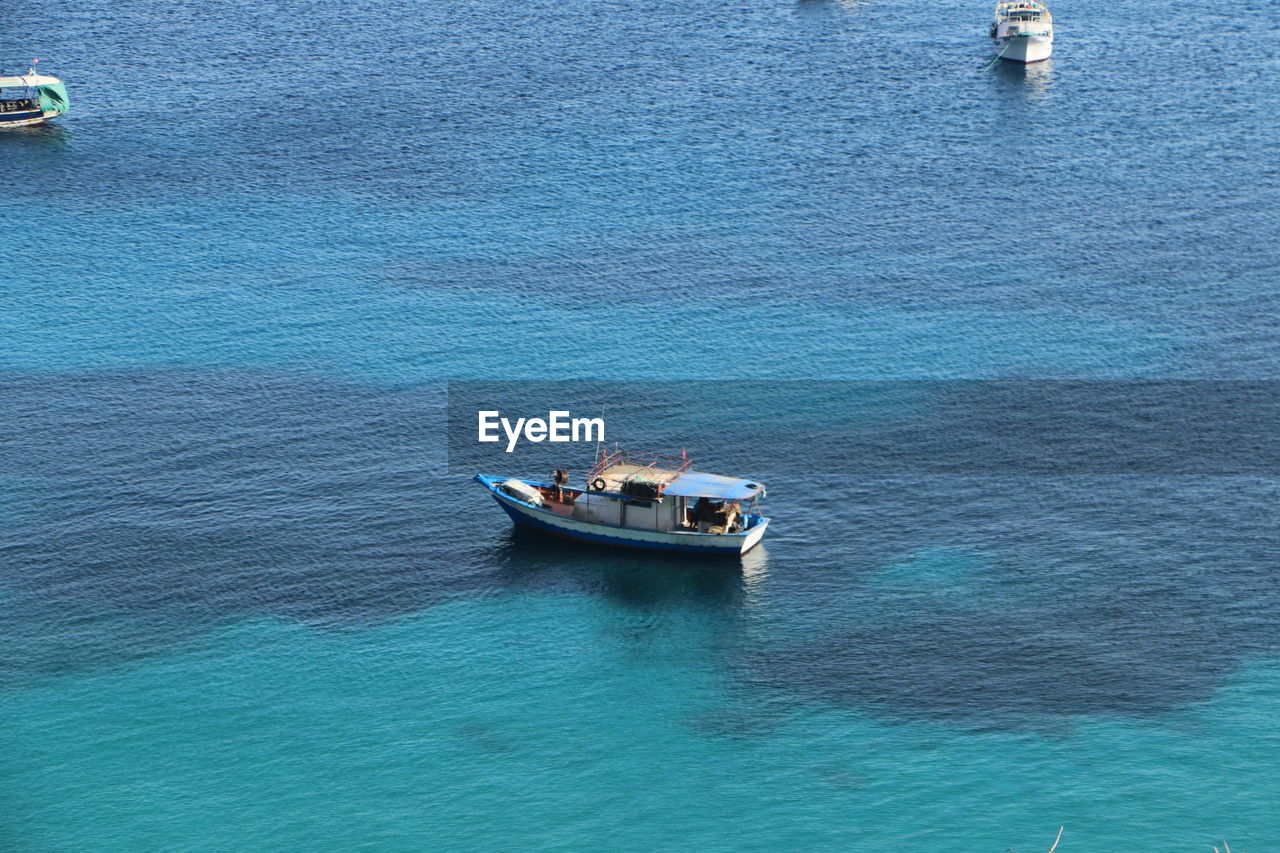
[476,475,769,556]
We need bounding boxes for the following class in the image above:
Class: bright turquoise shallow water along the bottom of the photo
[5,596,1280,850]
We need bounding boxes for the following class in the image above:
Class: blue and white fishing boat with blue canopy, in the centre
[475,451,769,556]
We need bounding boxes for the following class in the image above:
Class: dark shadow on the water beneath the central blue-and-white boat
[494,526,768,607]
